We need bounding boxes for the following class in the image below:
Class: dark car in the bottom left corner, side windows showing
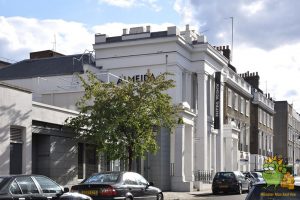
[0,175,91,200]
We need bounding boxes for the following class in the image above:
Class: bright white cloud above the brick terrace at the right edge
[233,43,300,111]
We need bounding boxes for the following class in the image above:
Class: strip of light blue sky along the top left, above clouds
[0,0,180,27]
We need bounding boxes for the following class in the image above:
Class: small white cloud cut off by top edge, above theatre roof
[99,0,162,12]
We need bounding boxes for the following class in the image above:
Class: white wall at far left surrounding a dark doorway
[0,83,32,174]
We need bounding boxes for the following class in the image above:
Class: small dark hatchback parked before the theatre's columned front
[212,171,251,194]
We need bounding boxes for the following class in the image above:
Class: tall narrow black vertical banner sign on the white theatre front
[214,72,221,129]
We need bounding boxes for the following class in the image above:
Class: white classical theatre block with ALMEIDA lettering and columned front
[94,25,251,191]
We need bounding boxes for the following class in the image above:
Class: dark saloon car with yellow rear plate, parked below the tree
[71,171,164,200]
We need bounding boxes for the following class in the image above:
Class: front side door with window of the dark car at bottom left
[33,175,63,200]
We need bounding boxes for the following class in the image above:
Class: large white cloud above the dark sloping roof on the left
[0,17,94,60]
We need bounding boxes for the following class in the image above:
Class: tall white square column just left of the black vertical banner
[195,72,208,170]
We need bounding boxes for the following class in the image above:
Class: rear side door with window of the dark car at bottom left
[16,176,47,200]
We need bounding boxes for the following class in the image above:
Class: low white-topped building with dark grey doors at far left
[0,82,78,186]
